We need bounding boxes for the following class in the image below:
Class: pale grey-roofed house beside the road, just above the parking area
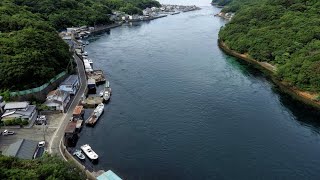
[44,89,70,111]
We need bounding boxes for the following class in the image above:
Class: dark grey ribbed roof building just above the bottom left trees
[2,139,38,159]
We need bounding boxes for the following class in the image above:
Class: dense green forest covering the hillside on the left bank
[0,0,160,92]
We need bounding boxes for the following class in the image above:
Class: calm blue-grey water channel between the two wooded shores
[78,1,320,180]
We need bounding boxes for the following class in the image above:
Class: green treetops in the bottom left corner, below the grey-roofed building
[0,155,86,180]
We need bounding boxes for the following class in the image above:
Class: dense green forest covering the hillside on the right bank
[219,0,320,91]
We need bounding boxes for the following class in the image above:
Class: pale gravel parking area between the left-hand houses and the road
[0,113,63,151]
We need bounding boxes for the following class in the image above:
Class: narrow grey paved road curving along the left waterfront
[48,52,87,156]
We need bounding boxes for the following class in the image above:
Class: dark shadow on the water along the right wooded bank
[226,55,320,134]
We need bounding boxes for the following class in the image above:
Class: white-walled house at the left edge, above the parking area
[1,102,38,122]
